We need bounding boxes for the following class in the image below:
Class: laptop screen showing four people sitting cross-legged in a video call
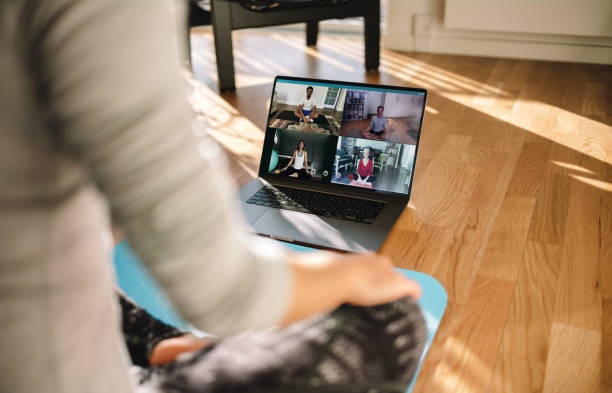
[260,77,427,194]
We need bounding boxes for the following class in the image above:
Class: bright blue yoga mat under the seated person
[113,242,448,393]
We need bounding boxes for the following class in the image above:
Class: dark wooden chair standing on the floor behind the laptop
[188,0,380,91]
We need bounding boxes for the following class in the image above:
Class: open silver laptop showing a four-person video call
[240,76,427,252]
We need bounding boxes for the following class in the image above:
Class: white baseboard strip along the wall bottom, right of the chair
[382,34,612,64]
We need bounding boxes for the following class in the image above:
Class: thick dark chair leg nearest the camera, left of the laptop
[211,0,236,91]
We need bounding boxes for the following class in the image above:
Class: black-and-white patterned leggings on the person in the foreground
[122,292,427,393]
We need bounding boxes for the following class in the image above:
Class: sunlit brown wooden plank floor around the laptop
[192,31,612,393]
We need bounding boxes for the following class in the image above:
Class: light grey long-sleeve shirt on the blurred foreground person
[0,0,291,393]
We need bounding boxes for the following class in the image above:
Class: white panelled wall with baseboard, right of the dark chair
[383,0,612,64]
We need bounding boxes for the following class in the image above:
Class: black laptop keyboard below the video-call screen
[247,185,385,224]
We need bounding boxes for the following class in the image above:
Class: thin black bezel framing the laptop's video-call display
[259,75,427,199]
